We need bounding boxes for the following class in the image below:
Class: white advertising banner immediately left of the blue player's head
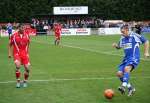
[98,28,121,35]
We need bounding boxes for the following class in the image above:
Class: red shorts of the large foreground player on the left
[14,53,30,65]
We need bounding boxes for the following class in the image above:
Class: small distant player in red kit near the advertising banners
[54,23,61,45]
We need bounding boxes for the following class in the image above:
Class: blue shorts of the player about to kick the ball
[118,59,140,72]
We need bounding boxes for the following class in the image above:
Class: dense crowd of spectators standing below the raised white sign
[31,17,104,28]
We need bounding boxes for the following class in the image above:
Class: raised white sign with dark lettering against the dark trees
[53,6,88,15]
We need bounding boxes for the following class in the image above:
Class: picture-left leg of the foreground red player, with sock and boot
[15,60,21,88]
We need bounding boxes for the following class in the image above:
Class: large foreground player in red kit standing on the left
[8,25,30,88]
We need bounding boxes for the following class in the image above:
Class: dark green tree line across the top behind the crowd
[0,0,150,22]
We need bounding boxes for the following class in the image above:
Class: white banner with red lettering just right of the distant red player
[61,28,91,35]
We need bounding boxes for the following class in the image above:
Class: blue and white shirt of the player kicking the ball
[118,32,147,60]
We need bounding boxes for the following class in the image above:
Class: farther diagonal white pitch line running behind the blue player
[33,40,150,61]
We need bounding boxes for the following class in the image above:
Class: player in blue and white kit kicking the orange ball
[112,25,149,96]
